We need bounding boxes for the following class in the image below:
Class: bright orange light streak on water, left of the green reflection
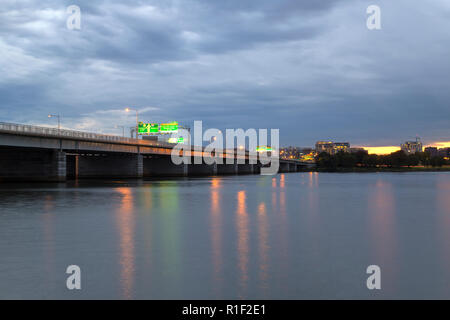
[116,188,135,299]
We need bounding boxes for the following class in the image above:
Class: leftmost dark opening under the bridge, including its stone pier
[0,148,66,181]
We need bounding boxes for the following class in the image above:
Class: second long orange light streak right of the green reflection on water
[236,190,249,299]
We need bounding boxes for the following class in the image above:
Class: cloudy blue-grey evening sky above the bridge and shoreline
[0,0,450,146]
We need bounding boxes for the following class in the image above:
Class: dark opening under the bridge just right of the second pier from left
[144,156,188,177]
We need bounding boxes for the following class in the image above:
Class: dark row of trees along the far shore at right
[316,150,450,169]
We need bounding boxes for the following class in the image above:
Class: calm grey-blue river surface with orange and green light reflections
[0,172,450,299]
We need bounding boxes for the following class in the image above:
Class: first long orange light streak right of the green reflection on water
[211,178,223,297]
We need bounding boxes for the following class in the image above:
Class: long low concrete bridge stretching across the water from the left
[0,123,307,181]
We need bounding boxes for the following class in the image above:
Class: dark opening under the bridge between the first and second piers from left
[77,153,143,178]
